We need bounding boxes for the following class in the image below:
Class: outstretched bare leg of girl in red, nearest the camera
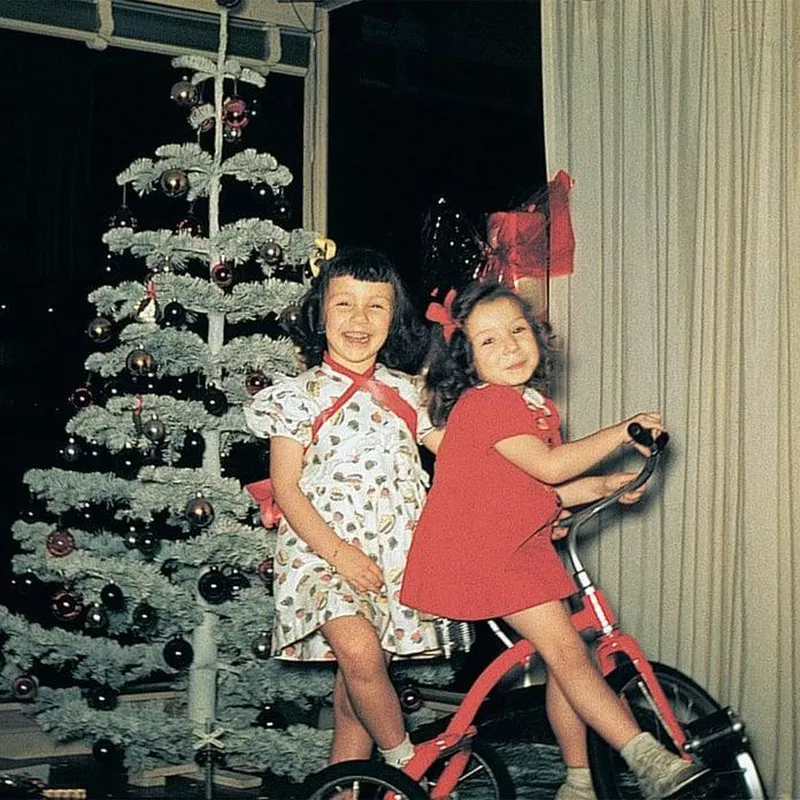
[505,600,640,750]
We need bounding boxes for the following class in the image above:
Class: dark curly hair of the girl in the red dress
[425,281,556,427]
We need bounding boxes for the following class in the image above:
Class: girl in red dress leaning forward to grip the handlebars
[401,283,704,800]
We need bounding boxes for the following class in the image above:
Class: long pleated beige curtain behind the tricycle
[541,0,800,798]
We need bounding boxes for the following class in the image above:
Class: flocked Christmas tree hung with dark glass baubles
[0,2,346,780]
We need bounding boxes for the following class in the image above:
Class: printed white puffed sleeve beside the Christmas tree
[243,380,317,447]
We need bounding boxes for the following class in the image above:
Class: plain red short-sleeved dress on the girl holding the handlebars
[400,385,576,620]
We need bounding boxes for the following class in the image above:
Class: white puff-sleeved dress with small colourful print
[244,363,437,661]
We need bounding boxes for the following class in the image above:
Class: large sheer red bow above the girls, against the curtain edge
[476,170,575,287]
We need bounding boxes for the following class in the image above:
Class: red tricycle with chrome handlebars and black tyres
[306,424,766,800]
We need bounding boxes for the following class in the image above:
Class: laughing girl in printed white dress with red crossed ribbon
[245,249,440,766]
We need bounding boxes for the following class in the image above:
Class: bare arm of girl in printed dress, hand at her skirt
[269,436,383,592]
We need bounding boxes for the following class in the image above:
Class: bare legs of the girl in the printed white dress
[322,616,406,761]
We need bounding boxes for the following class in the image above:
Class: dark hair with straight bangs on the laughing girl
[284,247,430,373]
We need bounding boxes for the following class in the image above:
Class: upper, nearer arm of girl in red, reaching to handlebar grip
[495,412,661,486]
